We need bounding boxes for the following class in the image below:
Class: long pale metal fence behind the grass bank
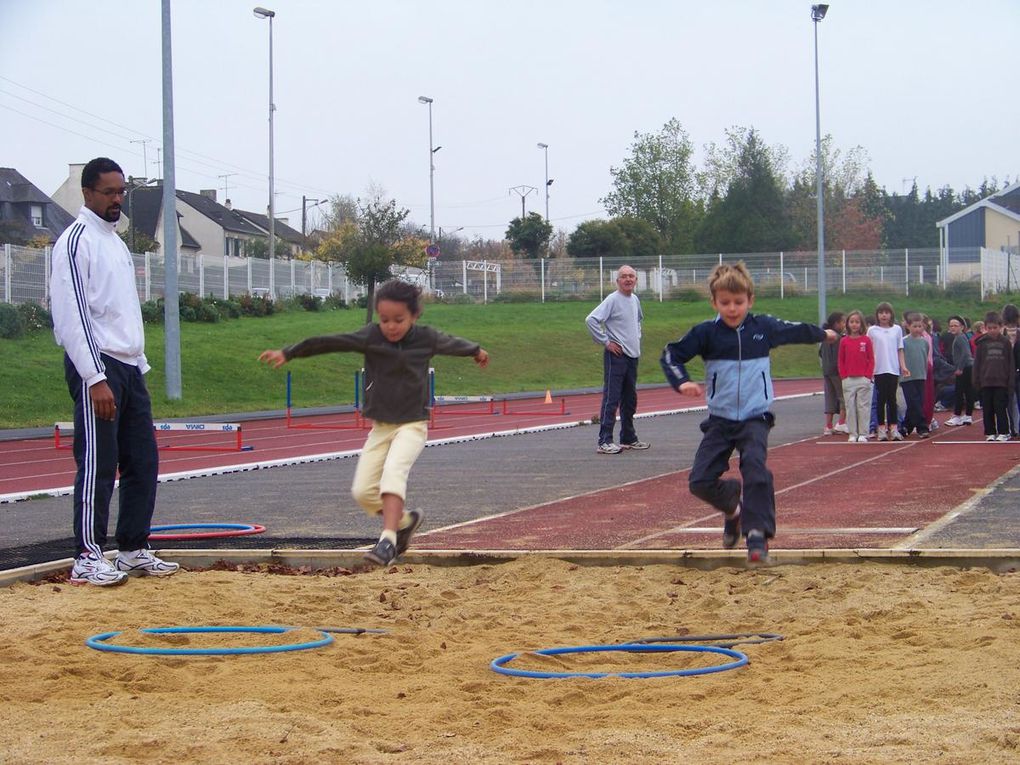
[0,245,983,306]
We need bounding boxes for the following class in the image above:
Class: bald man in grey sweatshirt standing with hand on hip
[585,265,649,454]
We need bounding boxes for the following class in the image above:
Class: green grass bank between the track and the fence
[0,294,1002,428]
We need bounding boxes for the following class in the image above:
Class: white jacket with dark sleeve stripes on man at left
[50,206,149,388]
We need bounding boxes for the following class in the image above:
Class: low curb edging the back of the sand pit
[0,548,1020,587]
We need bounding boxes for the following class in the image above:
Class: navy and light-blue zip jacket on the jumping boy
[662,313,825,420]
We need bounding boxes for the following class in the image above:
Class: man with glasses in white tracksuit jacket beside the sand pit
[50,157,179,585]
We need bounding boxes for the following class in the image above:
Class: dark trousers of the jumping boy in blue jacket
[689,412,775,539]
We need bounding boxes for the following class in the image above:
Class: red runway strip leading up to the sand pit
[417,415,1020,550]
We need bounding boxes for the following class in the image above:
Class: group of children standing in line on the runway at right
[818,302,1020,443]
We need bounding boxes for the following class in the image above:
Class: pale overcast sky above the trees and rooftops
[0,0,1020,239]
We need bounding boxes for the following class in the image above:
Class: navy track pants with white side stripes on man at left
[64,354,159,555]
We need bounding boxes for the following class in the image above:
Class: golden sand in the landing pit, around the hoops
[0,559,1020,765]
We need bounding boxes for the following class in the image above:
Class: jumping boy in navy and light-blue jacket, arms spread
[662,262,837,565]
